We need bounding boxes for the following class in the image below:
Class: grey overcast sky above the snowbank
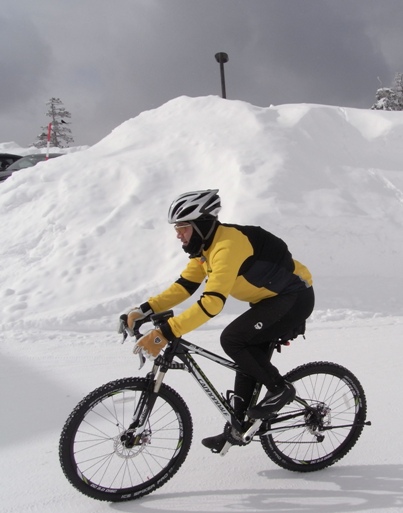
[0,0,403,146]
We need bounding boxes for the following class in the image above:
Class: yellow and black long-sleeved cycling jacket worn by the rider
[148,223,312,337]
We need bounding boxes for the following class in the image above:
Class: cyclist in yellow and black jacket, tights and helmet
[120,189,314,452]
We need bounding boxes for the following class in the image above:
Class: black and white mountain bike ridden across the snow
[59,311,371,502]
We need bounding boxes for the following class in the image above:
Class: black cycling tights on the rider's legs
[221,287,315,414]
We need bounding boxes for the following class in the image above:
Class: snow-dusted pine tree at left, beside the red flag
[33,98,74,148]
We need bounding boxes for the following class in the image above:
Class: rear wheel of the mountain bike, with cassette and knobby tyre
[260,362,367,472]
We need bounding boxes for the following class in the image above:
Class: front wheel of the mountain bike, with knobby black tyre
[59,378,193,502]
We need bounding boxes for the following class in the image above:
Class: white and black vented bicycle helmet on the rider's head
[168,189,221,224]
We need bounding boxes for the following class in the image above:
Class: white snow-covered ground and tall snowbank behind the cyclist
[0,97,403,513]
